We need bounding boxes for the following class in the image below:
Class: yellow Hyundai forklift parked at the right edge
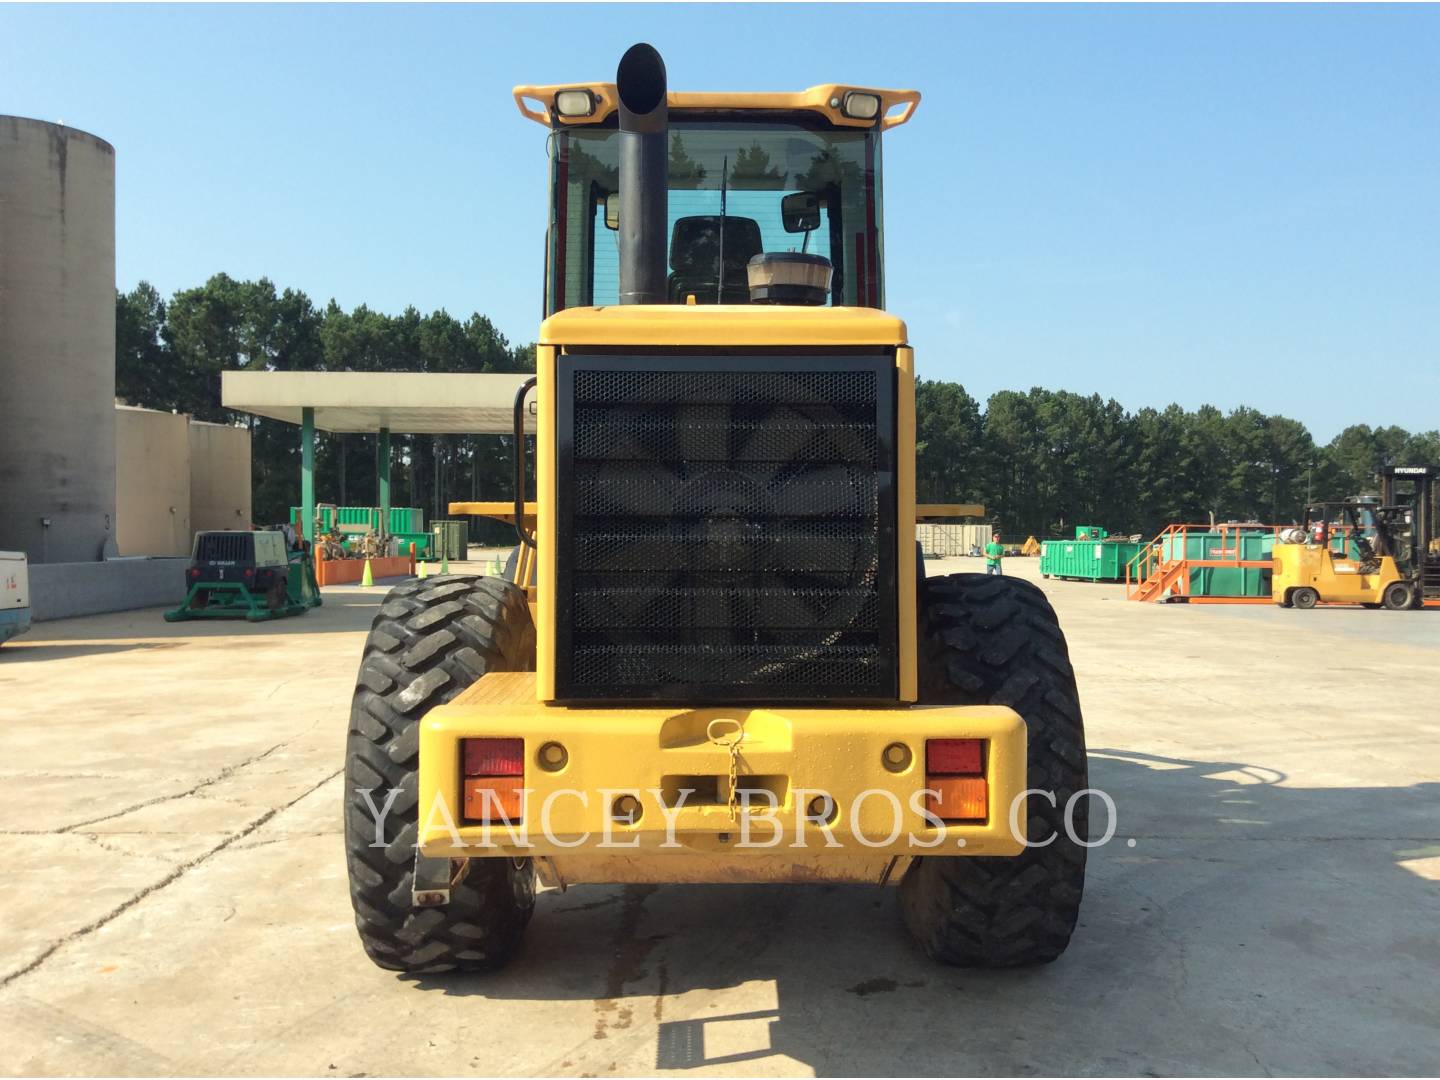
[1272,465,1440,611]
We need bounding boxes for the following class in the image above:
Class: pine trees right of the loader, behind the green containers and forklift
[916,380,1440,540]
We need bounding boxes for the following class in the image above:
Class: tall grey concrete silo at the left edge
[0,117,115,563]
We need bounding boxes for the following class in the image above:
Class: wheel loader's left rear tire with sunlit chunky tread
[344,575,536,973]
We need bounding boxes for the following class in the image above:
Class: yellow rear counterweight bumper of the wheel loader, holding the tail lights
[419,672,1025,883]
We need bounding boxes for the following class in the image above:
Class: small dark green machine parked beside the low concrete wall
[166,527,320,622]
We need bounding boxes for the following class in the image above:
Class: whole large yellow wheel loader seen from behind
[346,45,1090,972]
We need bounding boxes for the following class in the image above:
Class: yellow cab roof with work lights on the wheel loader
[514,82,920,131]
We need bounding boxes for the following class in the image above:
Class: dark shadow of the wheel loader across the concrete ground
[415,749,1440,1076]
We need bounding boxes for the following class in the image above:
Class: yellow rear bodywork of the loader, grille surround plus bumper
[434,305,1025,884]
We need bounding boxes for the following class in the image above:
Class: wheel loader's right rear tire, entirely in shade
[900,573,1089,968]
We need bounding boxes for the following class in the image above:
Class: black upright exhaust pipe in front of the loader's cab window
[615,42,670,304]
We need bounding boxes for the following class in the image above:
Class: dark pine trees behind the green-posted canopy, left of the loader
[115,274,534,543]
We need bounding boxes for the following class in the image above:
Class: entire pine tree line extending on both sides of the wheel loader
[115,274,1440,543]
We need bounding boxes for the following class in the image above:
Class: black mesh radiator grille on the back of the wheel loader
[556,356,896,700]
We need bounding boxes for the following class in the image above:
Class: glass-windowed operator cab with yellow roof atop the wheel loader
[541,72,898,315]
